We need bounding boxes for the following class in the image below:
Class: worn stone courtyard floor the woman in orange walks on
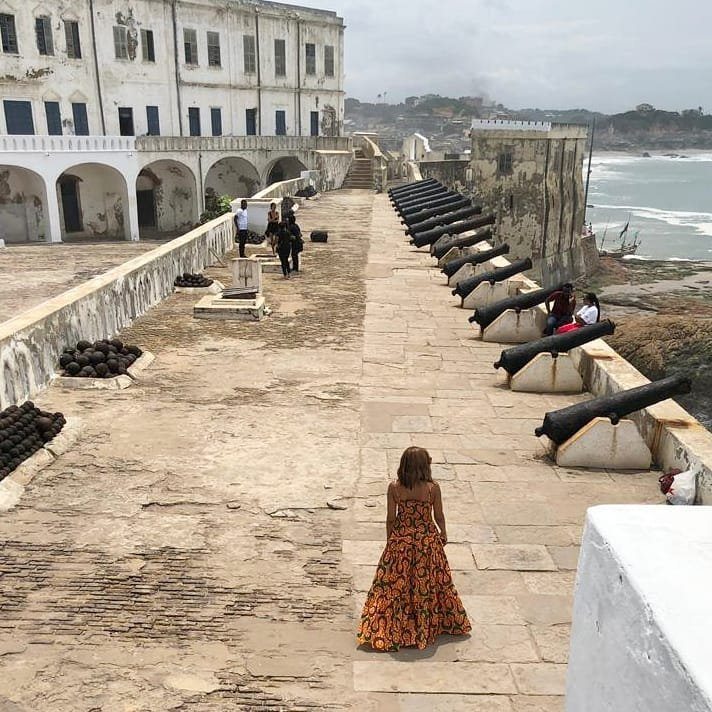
[0,191,660,712]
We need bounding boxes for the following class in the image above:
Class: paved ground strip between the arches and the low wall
[0,241,160,322]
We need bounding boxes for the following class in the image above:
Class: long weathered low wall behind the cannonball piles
[0,214,233,408]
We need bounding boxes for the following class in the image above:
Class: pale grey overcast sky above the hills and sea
[287,0,712,113]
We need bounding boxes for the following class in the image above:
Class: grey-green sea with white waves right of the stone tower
[584,152,712,261]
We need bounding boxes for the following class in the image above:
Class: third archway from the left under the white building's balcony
[136,159,199,237]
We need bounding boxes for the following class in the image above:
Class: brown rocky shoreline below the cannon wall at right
[577,258,712,430]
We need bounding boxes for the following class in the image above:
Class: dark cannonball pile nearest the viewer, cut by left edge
[0,401,67,480]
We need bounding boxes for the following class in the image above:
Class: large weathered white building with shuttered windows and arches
[0,0,350,241]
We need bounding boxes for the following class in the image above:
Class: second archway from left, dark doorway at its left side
[56,163,131,240]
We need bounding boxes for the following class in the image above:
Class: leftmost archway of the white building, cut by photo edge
[0,165,50,243]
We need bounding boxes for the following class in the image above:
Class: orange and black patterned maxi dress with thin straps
[357,486,472,650]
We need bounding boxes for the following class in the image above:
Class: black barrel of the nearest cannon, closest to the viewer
[534,374,692,445]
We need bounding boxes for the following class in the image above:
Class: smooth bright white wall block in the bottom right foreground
[566,506,712,712]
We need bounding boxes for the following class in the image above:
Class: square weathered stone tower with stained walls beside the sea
[471,120,598,284]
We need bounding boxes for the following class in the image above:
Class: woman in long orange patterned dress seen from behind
[357,447,472,651]
